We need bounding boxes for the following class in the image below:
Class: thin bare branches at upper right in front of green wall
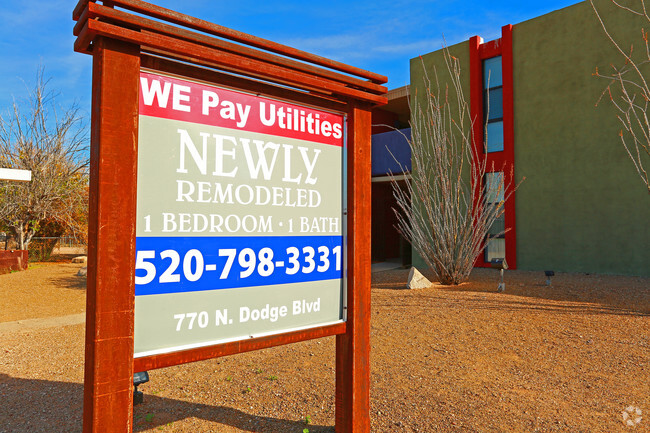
[589,0,650,194]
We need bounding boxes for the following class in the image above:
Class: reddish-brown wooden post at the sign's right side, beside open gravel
[336,103,371,433]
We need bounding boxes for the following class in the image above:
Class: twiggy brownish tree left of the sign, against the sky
[0,68,88,249]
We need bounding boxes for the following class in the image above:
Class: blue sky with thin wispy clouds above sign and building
[0,0,577,113]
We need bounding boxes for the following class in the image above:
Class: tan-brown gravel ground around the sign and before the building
[0,263,650,433]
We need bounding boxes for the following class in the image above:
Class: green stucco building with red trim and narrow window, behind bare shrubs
[402,0,650,276]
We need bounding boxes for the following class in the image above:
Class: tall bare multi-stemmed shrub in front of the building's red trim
[393,48,516,284]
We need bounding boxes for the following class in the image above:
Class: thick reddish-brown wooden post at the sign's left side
[83,37,140,433]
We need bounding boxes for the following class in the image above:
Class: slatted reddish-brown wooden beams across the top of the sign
[73,0,387,105]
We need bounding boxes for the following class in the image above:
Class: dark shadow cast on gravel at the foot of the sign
[0,373,334,433]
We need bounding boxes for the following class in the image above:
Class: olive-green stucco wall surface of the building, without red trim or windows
[411,1,650,276]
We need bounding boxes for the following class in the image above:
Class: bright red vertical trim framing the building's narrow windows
[469,25,517,269]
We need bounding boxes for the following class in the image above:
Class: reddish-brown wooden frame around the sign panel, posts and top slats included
[73,0,387,433]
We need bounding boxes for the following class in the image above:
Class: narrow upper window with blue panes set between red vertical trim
[483,56,503,153]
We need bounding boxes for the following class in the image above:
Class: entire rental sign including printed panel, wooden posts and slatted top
[73,0,387,433]
